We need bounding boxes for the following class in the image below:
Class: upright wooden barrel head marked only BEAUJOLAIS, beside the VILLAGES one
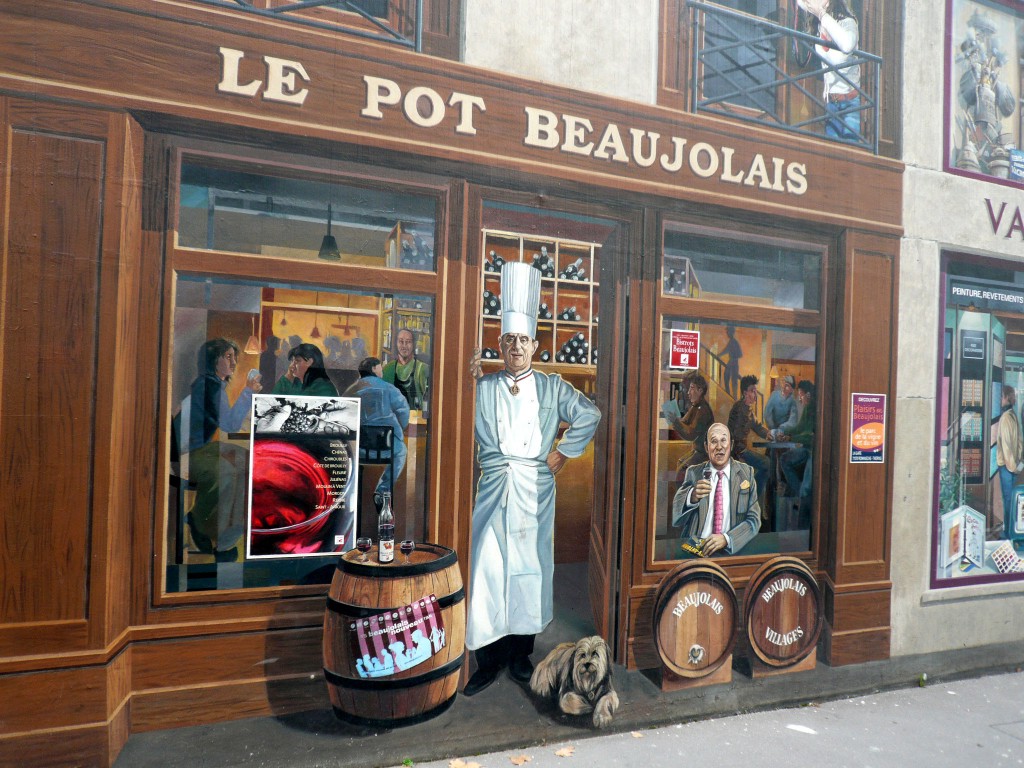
[653,559,739,678]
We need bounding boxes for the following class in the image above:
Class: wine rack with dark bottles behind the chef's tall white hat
[479,229,601,373]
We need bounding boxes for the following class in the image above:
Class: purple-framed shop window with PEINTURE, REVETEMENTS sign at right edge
[933,257,1024,586]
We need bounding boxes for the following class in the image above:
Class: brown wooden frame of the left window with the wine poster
[153,136,451,607]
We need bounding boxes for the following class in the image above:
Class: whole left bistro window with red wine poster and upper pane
[158,150,442,595]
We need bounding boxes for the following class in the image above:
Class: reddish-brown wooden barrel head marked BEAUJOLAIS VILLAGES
[743,556,823,668]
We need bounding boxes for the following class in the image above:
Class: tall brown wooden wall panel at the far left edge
[0,128,104,624]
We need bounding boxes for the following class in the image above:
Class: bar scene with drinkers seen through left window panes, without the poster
[165,153,435,592]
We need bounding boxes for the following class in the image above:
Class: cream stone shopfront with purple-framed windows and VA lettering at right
[892,2,1024,653]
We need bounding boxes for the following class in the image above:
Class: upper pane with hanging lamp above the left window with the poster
[177,159,436,271]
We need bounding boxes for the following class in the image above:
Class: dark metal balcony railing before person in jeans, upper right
[686,0,882,154]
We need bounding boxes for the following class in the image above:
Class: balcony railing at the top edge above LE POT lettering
[196,0,423,51]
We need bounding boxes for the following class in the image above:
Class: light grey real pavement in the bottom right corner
[396,673,1024,768]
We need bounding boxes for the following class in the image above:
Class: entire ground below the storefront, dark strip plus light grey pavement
[116,641,1024,768]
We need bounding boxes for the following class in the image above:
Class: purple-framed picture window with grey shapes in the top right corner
[946,0,1024,184]
